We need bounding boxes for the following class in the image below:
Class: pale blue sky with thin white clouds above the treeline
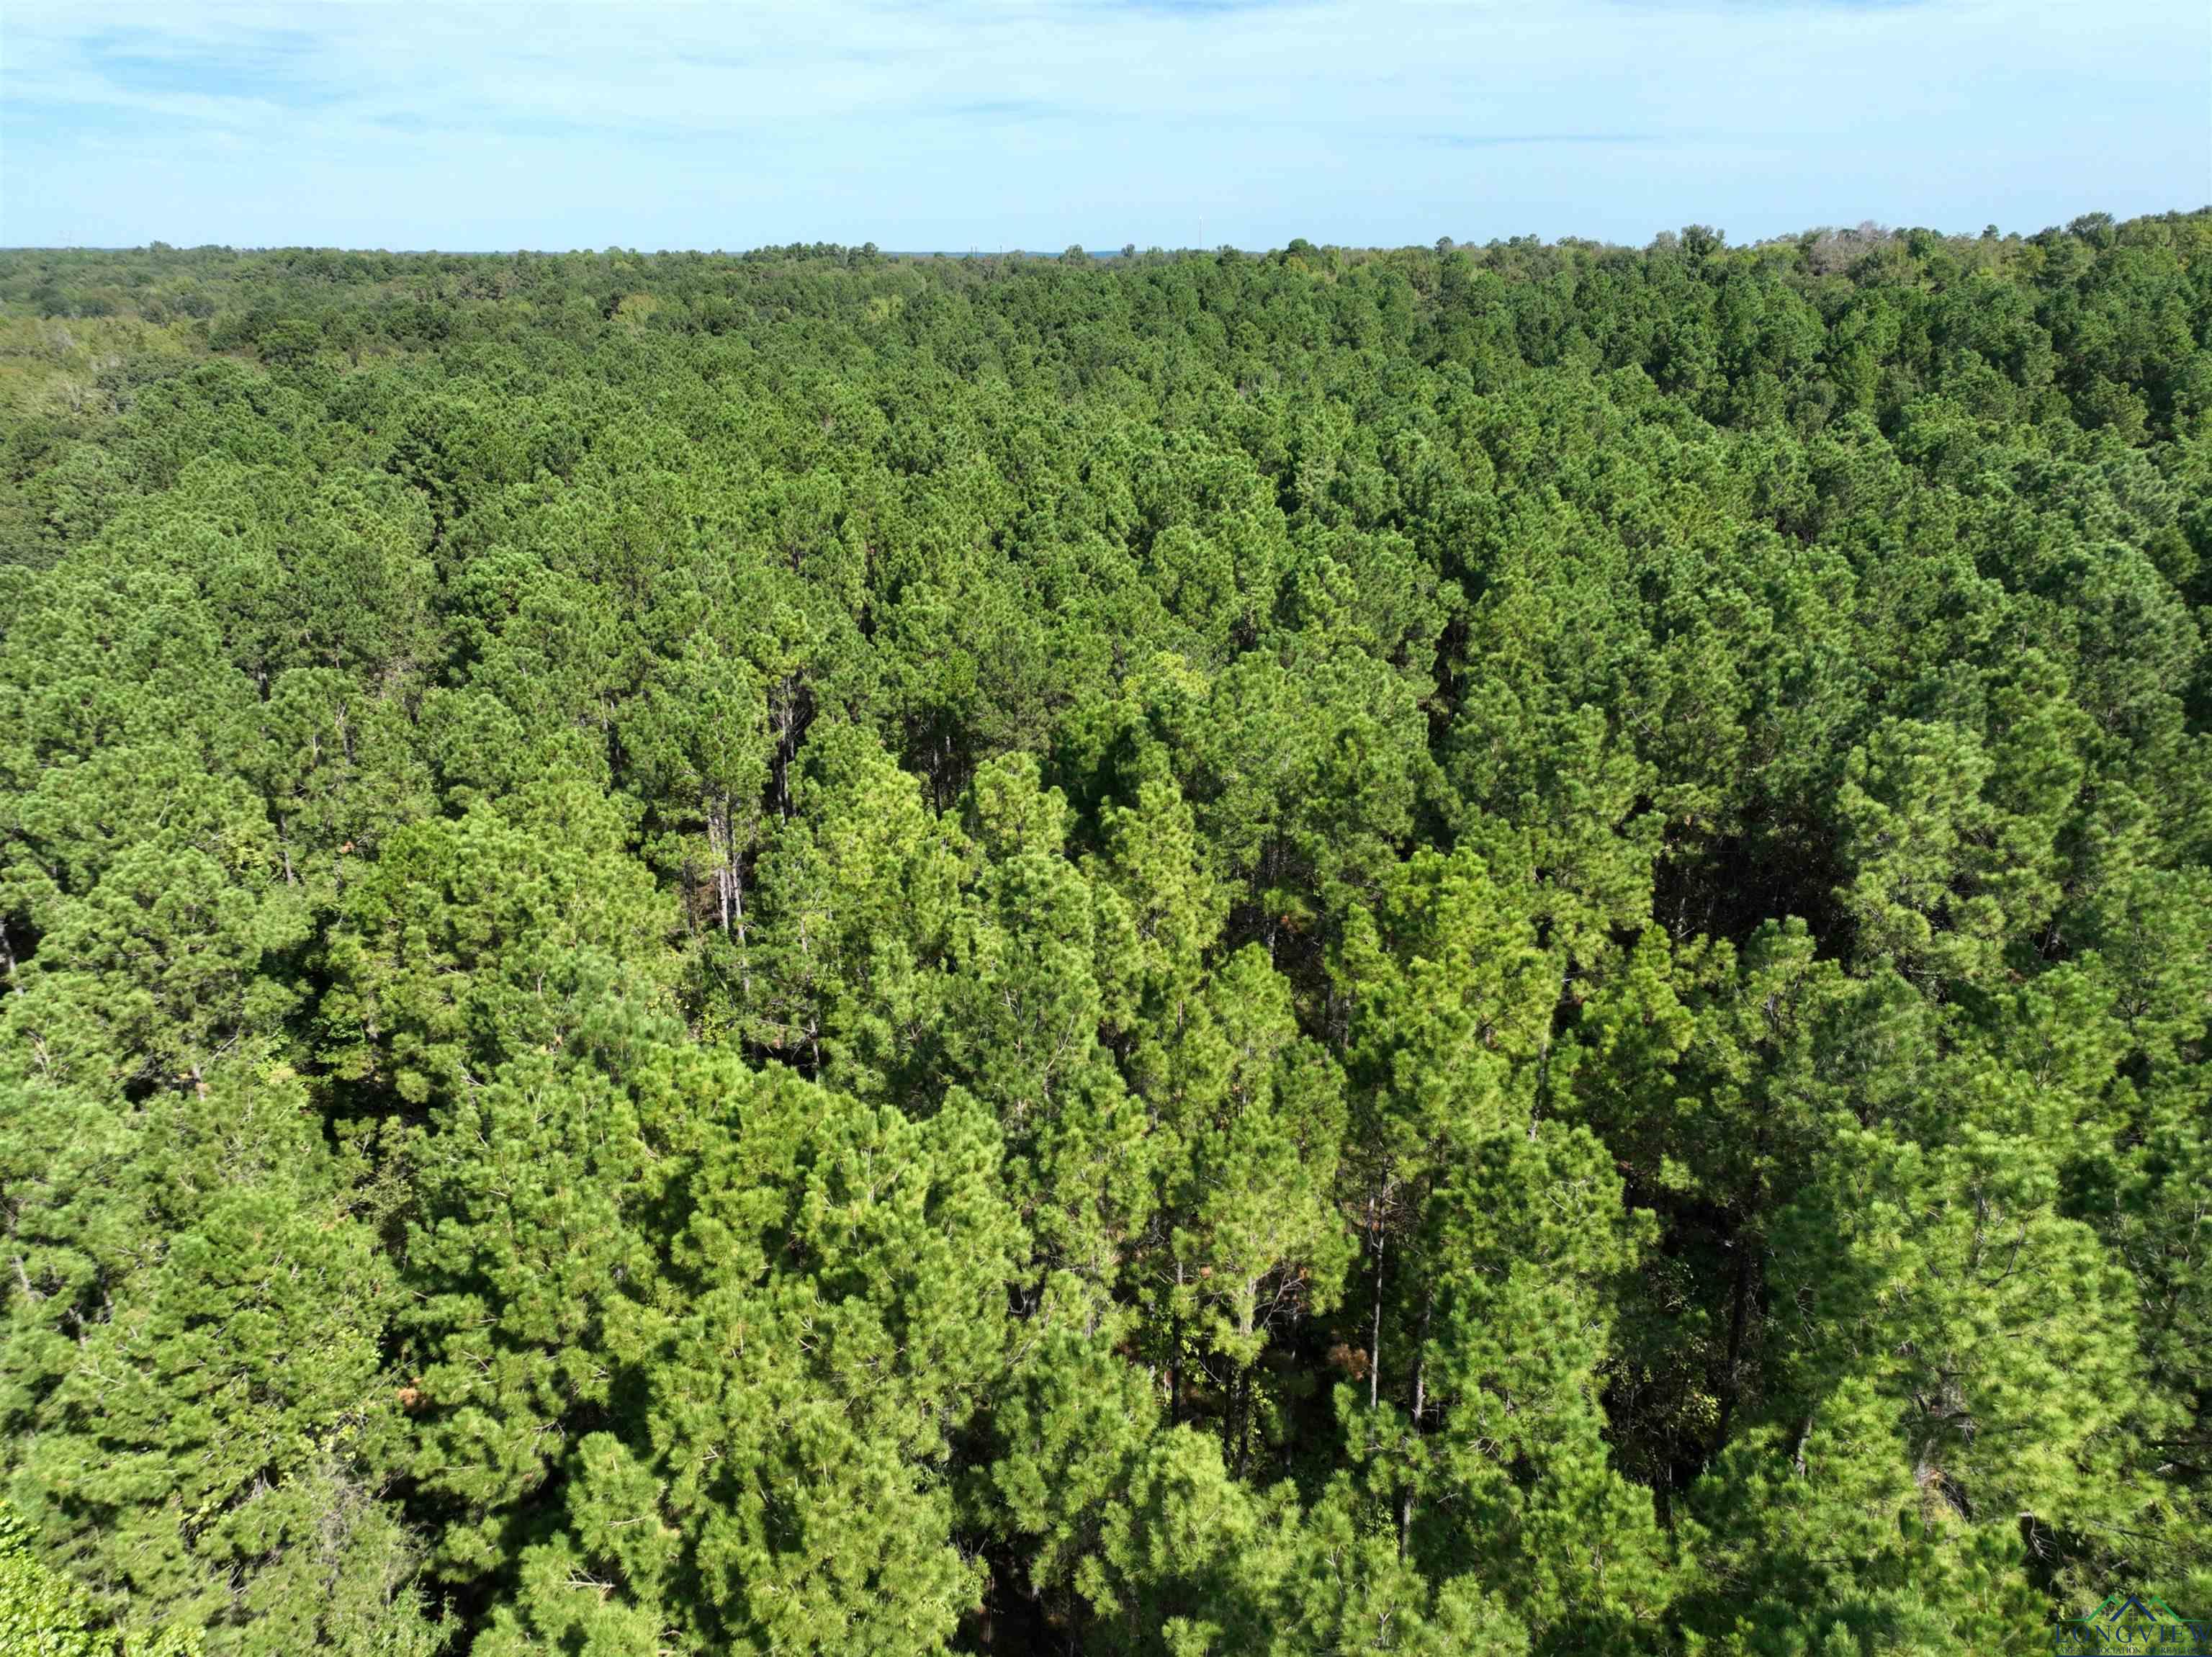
[0,0,2212,250]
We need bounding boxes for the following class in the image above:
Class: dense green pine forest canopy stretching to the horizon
[0,212,2212,1657]
